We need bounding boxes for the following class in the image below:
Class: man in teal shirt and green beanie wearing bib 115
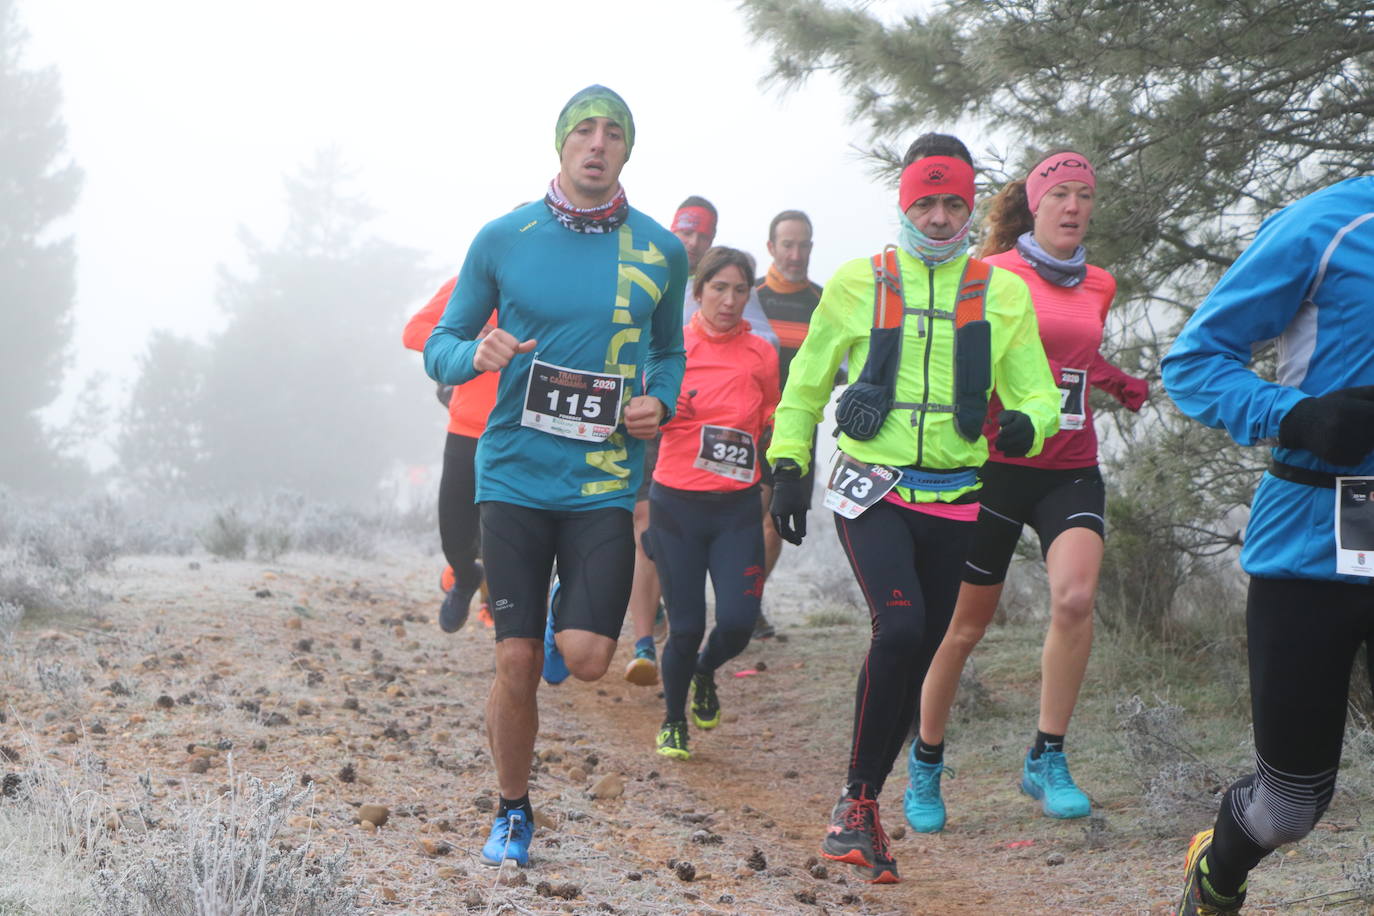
[425,85,687,865]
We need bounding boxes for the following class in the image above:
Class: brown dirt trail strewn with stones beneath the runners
[0,556,1178,915]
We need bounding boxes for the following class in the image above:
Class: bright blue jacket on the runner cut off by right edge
[1162,177,1374,585]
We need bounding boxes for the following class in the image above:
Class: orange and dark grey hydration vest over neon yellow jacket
[835,244,992,442]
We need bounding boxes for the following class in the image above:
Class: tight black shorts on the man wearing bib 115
[482,503,635,641]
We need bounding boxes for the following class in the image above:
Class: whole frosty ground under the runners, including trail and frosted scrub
[0,538,1374,913]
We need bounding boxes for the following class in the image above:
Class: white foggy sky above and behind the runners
[19,0,906,436]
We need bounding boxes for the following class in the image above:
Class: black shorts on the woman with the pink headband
[963,461,1106,585]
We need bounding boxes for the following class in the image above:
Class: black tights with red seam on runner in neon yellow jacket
[835,503,974,797]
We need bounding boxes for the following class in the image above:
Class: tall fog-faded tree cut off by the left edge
[0,0,81,488]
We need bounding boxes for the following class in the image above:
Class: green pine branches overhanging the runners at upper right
[741,0,1374,300]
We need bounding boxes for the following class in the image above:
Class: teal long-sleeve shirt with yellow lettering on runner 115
[425,201,687,511]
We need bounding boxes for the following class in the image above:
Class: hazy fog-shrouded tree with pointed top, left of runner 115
[196,151,441,503]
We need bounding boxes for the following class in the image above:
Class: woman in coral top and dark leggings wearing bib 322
[649,247,779,759]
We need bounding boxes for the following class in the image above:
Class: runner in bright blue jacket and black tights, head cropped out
[1164,177,1374,915]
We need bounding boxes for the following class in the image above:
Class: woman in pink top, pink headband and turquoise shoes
[904,151,1149,832]
